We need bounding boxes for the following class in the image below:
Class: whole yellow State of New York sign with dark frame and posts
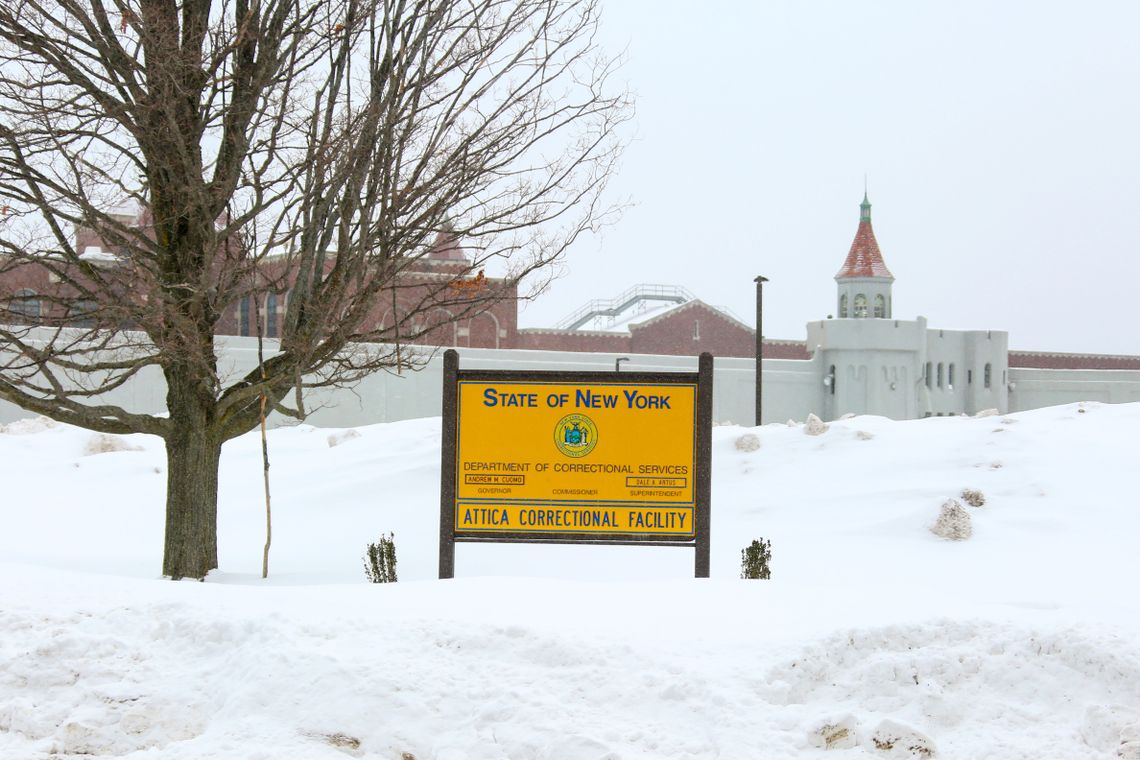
[440,351,713,578]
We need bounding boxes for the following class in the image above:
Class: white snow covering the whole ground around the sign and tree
[0,403,1140,760]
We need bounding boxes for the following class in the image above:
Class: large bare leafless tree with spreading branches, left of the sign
[0,0,630,578]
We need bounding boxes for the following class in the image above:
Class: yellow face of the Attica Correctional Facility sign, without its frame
[455,381,697,536]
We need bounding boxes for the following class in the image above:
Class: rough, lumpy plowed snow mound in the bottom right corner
[763,620,1140,760]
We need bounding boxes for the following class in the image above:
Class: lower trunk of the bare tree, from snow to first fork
[162,376,221,580]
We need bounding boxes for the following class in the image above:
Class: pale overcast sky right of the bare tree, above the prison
[520,0,1140,353]
